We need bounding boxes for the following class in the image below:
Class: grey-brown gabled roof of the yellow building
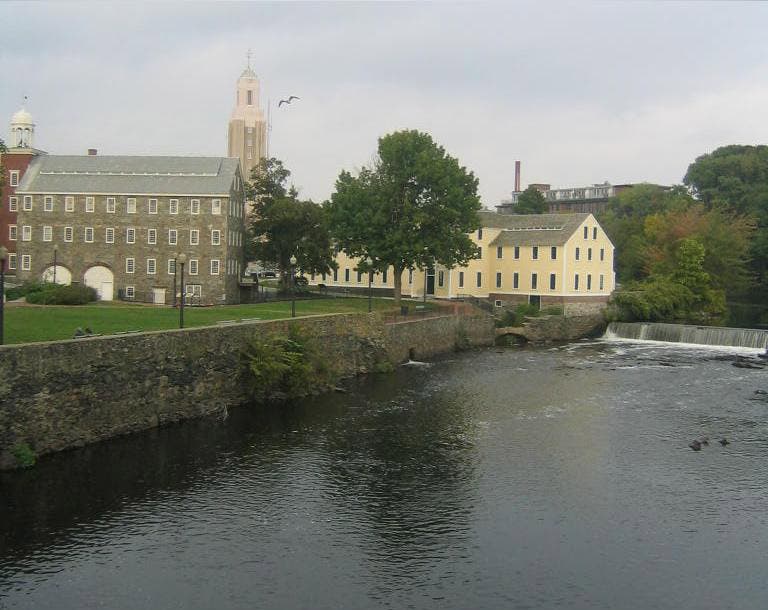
[480,212,589,246]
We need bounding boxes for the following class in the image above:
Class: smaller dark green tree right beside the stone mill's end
[246,158,336,286]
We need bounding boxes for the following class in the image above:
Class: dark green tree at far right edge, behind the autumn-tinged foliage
[683,145,768,302]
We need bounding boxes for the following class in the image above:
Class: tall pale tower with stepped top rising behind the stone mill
[228,62,267,180]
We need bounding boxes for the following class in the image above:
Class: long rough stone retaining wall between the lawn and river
[0,314,493,468]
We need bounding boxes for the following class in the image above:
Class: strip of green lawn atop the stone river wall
[5,297,430,344]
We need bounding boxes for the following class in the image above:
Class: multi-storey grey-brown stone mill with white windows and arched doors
[14,150,245,304]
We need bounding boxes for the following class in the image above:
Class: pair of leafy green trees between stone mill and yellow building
[247,130,481,305]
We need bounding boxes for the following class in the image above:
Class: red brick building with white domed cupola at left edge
[0,108,45,266]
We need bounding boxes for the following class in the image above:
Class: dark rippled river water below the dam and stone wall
[0,341,768,610]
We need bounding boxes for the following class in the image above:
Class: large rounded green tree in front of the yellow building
[326,130,481,305]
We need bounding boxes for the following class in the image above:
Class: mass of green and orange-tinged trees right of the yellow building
[598,146,768,323]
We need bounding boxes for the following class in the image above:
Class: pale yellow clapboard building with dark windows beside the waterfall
[310,212,615,311]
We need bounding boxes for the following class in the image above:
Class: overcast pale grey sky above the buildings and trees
[0,2,768,207]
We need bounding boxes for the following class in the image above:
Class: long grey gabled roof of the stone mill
[16,155,239,196]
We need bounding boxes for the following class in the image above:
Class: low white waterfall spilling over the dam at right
[604,322,768,349]
